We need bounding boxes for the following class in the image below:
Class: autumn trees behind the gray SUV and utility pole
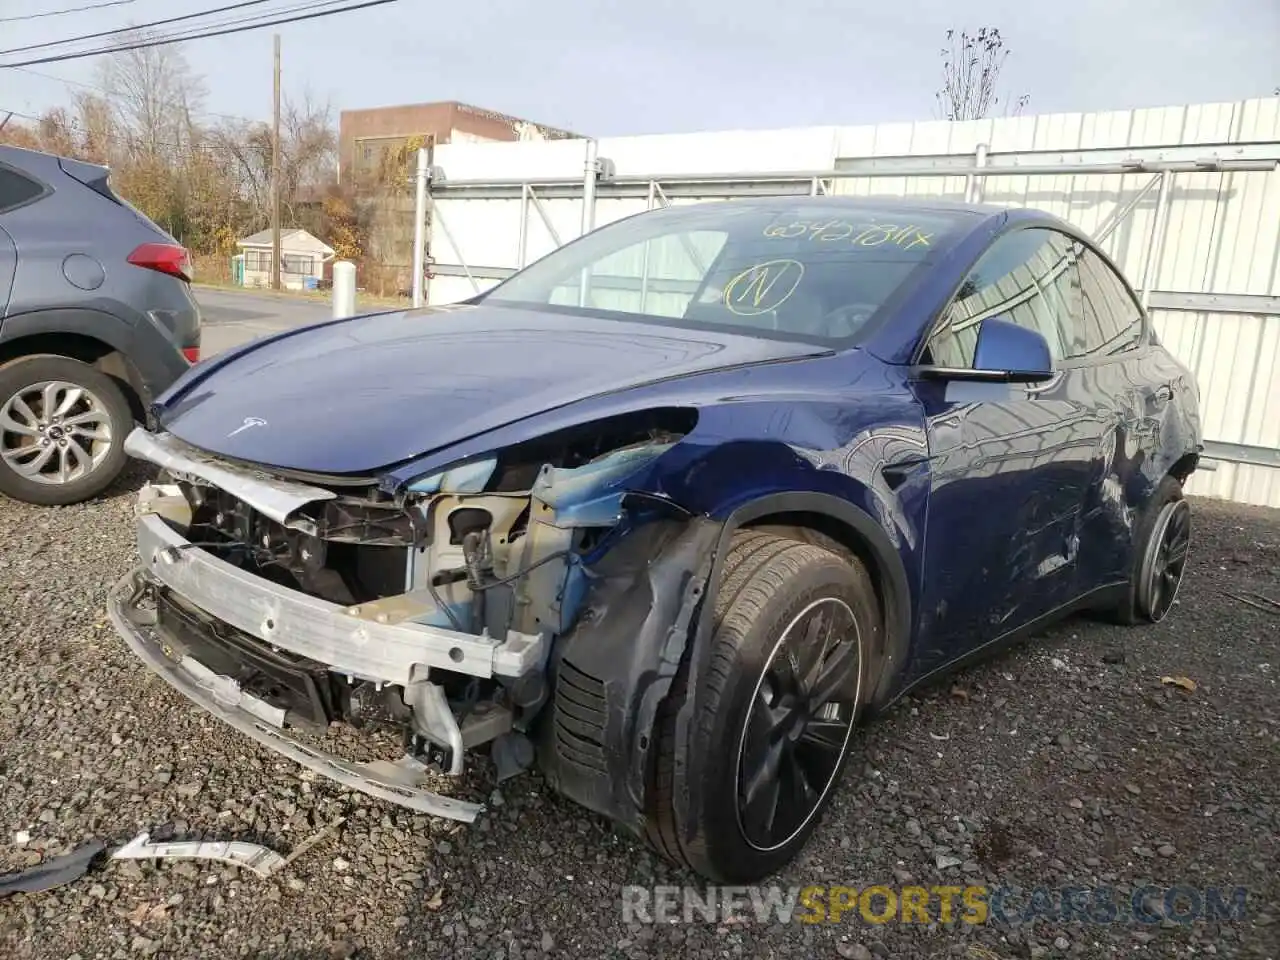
[0,45,364,288]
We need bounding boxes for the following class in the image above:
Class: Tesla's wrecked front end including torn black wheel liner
[109,408,723,828]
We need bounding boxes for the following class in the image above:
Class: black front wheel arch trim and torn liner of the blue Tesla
[539,490,913,836]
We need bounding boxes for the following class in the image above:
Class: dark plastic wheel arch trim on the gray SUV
[0,321,147,422]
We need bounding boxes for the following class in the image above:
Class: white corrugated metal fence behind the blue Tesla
[429,97,1280,507]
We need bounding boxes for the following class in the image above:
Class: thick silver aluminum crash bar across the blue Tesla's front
[138,513,543,686]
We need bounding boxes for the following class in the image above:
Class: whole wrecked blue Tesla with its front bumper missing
[111,198,1201,882]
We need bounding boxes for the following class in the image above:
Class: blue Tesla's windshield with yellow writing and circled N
[480,201,973,346]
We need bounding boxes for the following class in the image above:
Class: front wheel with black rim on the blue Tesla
[649,530,883,883]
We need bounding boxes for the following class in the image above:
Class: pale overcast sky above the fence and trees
[0,0,1280,136]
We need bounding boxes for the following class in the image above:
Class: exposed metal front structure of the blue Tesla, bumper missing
[111,416,680,819]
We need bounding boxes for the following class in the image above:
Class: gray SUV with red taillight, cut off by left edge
[0,146,200,504]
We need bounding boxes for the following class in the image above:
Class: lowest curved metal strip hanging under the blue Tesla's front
[108,566,484,823]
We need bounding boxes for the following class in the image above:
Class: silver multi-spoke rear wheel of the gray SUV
[0,356,133,507]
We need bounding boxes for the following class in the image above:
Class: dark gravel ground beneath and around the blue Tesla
[0,468,1280,960]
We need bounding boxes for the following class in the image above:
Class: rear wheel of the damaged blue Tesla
[1111,476,1192,626]
